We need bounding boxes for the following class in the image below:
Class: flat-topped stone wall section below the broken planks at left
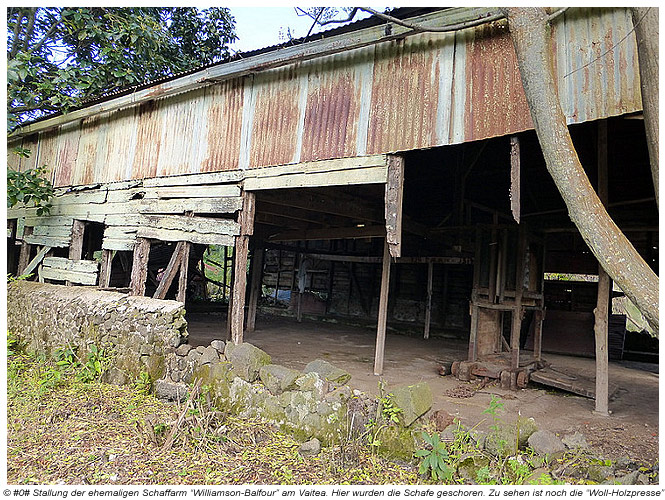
[7,281,187,384]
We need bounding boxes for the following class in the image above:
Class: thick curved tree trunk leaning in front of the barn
[502,8,658,331]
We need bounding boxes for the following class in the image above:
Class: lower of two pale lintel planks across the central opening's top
[244,166,388,191]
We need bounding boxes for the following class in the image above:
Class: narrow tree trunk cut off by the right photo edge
[630,7,658,204]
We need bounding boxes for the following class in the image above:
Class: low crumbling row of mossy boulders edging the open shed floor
[155,340,432,460]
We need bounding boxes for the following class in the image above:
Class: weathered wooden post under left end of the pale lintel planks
[230,191,256,345]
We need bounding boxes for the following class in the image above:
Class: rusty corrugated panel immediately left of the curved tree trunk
[464,22,533,141]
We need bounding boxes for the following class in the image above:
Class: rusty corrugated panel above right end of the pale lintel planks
[367,34,447,153]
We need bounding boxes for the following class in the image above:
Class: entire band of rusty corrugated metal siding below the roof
[33,8,641,185]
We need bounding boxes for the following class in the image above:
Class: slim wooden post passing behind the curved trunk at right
[593,120,612,415]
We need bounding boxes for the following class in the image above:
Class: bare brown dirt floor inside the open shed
[188,314,659,464]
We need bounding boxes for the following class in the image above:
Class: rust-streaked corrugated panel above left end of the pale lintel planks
[249,65,302,168]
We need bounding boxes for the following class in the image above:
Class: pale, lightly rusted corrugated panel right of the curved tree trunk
[553,8,642,123]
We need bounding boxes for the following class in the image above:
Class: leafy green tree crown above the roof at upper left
[7,7,236,130]
